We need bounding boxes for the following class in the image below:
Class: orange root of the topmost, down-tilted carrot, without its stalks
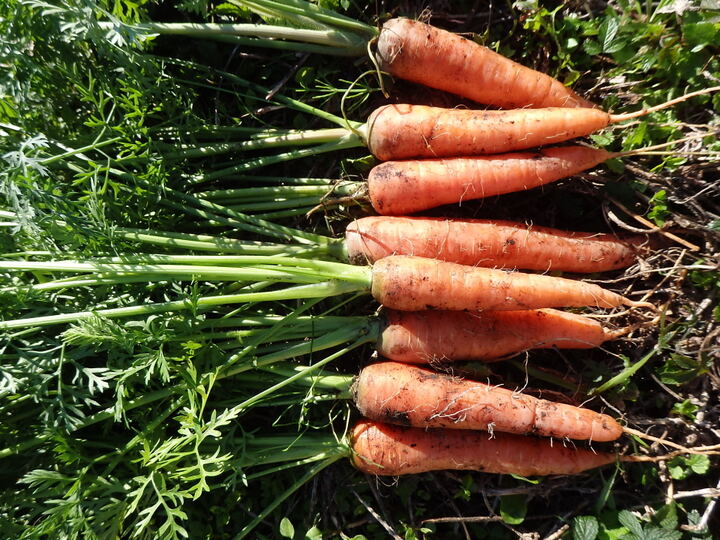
[376,18,593,108]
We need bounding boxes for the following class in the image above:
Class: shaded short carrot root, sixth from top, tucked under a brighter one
[375,309,615,364]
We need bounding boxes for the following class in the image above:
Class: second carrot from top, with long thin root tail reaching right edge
[366,87,720,161]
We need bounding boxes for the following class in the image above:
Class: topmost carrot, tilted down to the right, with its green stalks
[142,7,593,108]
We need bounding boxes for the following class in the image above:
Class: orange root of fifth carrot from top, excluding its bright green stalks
[371,255,652,311]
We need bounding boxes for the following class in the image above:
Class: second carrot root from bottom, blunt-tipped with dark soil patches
[353,362,623,442]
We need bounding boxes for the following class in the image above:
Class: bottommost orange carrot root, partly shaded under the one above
[350,420,617,476]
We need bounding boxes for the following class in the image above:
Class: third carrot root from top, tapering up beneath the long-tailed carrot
[367,146,614,216]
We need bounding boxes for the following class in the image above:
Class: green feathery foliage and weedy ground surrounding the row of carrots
[0,1,720,540]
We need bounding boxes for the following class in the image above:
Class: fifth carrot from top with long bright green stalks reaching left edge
[0,254,654,330]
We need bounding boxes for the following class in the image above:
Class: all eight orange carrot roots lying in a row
[129,0,714,486]
